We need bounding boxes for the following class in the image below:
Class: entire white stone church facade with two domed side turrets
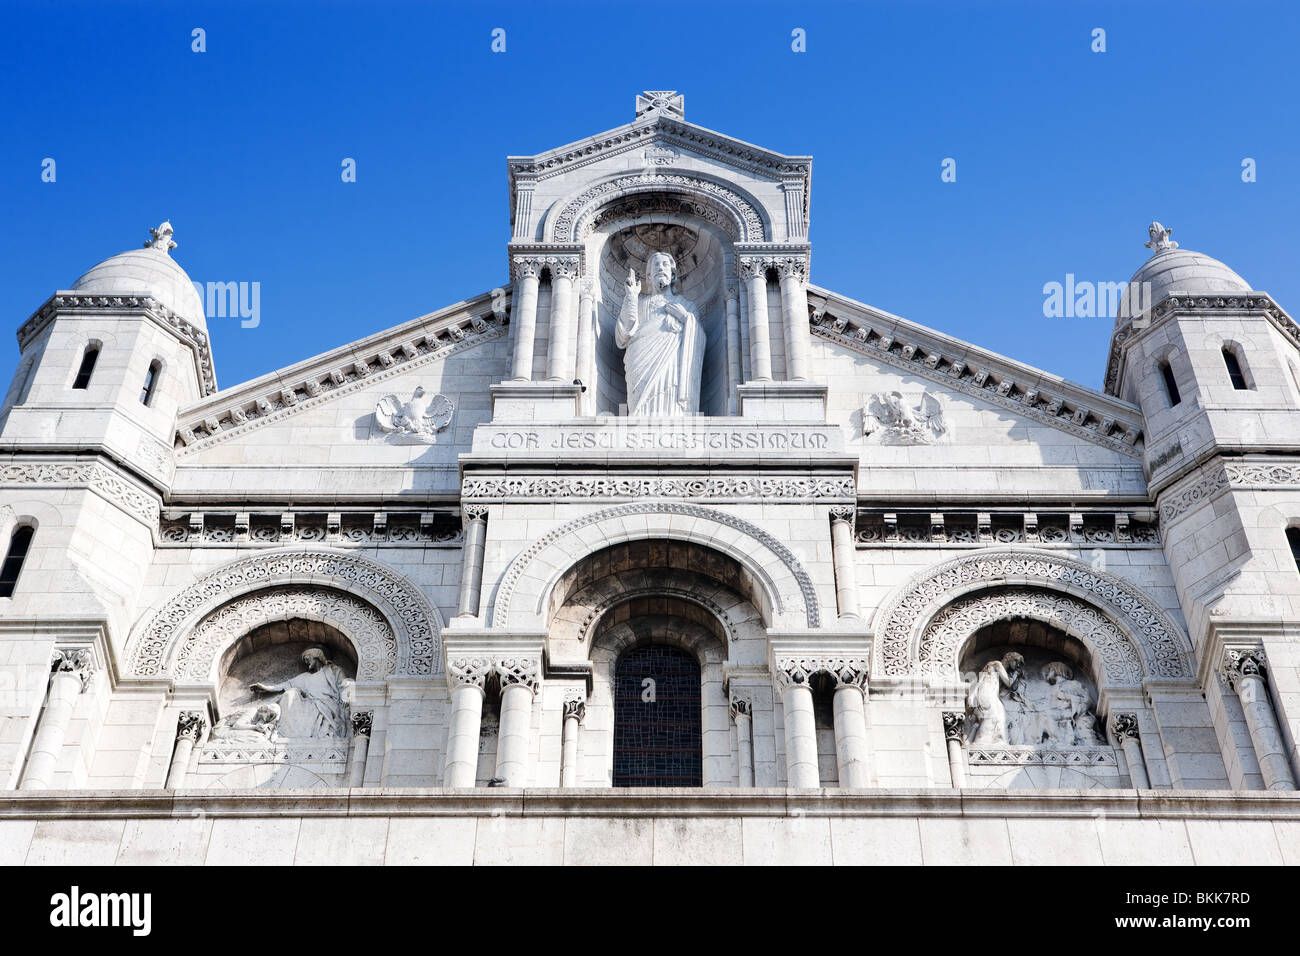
[0,91,1300,862]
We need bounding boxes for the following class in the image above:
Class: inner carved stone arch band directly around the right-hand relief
[919,588,1141,687]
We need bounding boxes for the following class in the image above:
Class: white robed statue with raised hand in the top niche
[614,252,705,418]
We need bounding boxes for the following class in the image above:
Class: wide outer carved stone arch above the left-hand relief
[126,549,442,680]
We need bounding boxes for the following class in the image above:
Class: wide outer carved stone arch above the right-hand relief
[872,550,1193,683]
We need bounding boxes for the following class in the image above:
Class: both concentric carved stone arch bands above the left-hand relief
[126,549,442,683]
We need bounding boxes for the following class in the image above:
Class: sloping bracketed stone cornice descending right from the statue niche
[810,293,1143,459]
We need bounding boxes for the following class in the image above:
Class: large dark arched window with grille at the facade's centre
[614,644,703,787]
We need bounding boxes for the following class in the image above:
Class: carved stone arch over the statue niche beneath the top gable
[549,172,767,242]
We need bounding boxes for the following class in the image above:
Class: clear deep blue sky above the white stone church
[0,0,1300,388]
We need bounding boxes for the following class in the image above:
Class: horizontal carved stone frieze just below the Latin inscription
[460,475,857,501]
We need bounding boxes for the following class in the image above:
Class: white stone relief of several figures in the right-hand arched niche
[966,652,1106,748]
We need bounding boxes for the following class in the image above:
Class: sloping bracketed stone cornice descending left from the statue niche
[176,303,507,457]
